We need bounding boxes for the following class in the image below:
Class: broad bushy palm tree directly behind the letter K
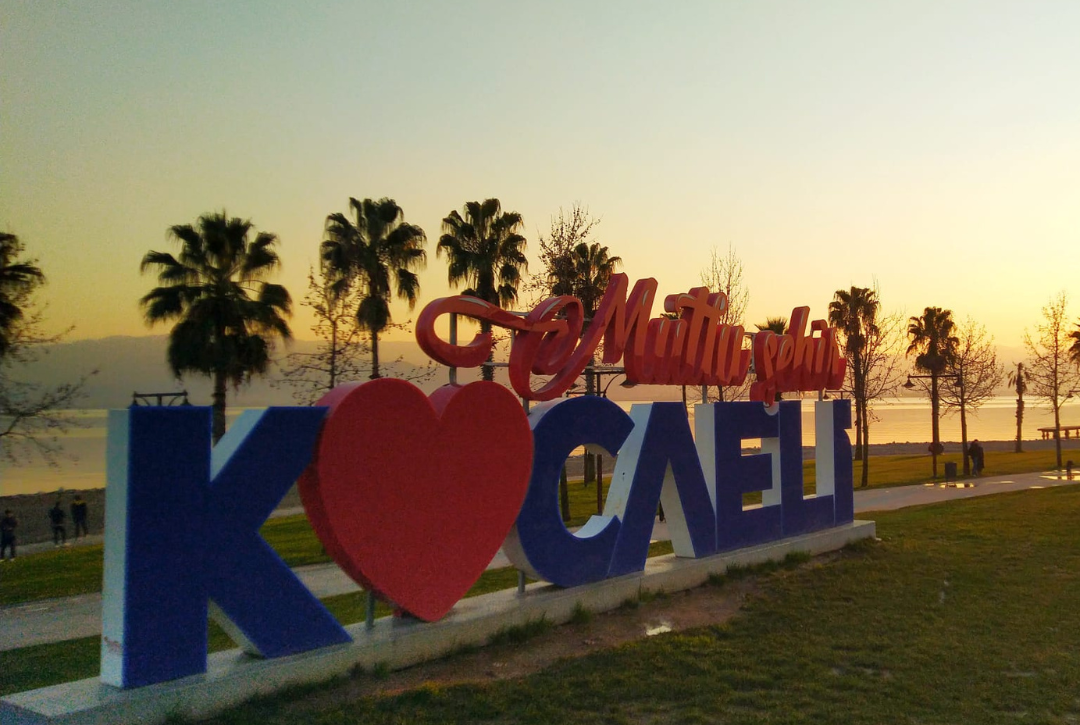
[139,212,292,443]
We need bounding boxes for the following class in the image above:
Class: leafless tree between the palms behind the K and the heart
[273,268,436,405]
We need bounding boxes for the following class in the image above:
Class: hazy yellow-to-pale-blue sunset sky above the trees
[0,0,1080,352]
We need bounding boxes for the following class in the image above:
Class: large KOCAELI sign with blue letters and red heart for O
[102,278,853,687]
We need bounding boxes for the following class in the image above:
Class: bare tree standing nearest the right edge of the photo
[1024,292,1080,469]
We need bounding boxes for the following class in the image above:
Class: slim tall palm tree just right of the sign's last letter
[828,286,879,486]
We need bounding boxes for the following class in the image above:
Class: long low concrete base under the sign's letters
[0,521,875,725]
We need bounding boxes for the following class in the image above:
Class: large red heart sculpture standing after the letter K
[299,378,532,621]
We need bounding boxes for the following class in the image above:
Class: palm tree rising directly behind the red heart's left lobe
[322,198,428,380]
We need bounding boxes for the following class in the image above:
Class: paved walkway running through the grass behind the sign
[0,472,1075,650]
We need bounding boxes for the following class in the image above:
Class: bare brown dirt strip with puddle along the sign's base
[274,574,768,716]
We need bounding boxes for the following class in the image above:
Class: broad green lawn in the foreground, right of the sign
[198,486,1080,725]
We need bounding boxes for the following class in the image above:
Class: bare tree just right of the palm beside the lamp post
[942,317,1004,475]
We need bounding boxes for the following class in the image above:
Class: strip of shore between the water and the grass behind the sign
[0,439,1080,543]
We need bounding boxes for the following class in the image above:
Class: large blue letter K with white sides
[102,407,349,687]
